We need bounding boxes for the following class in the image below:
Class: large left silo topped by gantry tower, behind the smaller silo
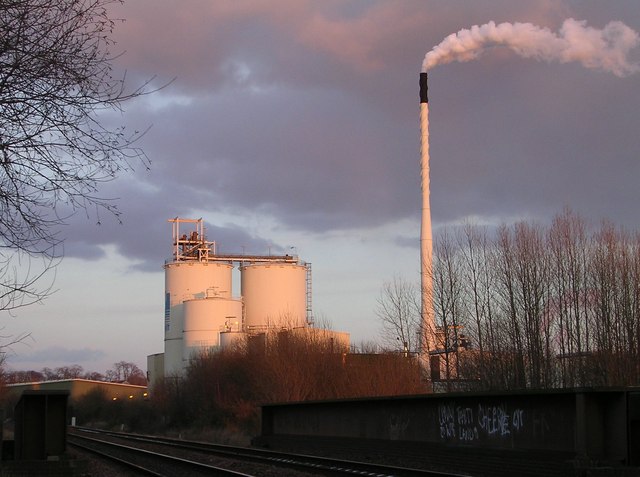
[164,261,233,376]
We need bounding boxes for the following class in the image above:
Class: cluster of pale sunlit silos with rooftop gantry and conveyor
[147,217,349,386]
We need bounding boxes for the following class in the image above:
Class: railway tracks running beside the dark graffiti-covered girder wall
[68,428,464,477]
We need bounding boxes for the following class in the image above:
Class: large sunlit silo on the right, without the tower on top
[240,262,307,331]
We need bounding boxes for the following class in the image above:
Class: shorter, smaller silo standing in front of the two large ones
[182,297,242,365]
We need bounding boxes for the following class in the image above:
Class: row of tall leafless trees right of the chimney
[433,210,640,389]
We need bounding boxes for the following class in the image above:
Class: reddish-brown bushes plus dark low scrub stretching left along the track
[61,330,427,436]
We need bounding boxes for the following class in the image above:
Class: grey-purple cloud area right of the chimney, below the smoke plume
[430,55,640,227]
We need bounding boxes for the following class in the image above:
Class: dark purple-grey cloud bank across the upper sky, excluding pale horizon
[58,0,640,269]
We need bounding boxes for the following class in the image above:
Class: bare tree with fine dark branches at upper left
[0,0,155,310]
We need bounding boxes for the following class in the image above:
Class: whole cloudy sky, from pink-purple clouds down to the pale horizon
[3,0,640,371]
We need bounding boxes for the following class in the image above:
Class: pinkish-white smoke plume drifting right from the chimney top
[422,18,640,76]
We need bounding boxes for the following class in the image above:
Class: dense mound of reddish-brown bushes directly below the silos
[152,332,426,433]
